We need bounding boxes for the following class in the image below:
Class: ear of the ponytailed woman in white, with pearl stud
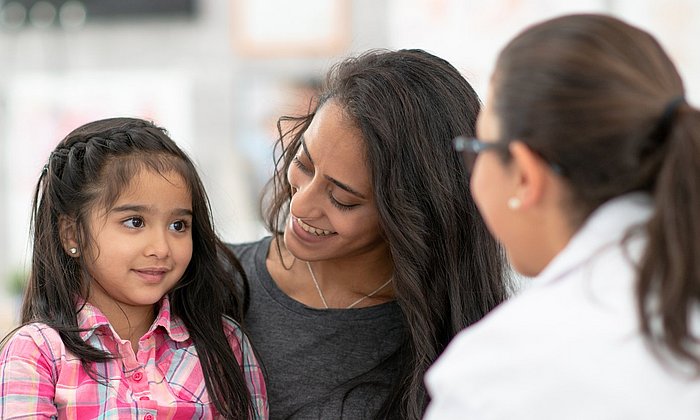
[508,140,549,209]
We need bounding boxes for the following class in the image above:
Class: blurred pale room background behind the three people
[0,0,700,335]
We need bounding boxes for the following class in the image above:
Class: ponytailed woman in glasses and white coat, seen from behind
[426,15,700,420]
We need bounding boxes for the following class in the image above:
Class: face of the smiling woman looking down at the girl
[284,100,389,261]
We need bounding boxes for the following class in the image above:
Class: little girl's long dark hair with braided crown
[22,118,252,418]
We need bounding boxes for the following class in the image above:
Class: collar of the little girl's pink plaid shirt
[76,295,190,342]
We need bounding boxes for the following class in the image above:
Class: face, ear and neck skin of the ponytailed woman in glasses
[471,84,575,276]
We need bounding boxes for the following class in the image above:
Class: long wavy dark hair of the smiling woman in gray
[266,50,508,419]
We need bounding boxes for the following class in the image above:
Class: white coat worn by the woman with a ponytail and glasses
[425,194,700,420]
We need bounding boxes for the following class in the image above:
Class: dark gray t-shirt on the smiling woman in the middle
[231,237,406,420]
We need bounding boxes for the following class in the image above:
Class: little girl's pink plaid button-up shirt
[0,297,268,420]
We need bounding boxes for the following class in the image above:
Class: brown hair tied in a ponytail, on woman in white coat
[493,15,700,369]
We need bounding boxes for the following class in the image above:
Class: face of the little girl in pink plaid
[82,169,192,313]
